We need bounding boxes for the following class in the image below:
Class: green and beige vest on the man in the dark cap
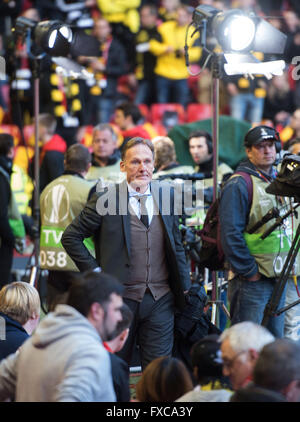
[244,176,300,278]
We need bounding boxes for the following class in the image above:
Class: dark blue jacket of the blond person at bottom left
[0,312,29,360]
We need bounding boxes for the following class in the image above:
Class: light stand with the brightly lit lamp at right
[185,5,286,323]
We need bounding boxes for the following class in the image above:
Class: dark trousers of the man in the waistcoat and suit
[118,291,174,370]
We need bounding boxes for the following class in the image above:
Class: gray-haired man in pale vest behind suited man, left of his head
[86,123,124,182]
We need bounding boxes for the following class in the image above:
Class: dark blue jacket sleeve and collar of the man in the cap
[220,160,276,278]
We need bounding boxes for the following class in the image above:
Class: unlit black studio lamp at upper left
[15,17,73,57]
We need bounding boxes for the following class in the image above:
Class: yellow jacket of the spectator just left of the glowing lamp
[150,21,201,79]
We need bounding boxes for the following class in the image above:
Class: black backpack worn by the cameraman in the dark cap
[199,171,253,271]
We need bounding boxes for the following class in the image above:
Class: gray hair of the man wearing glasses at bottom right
[220,321,275,353]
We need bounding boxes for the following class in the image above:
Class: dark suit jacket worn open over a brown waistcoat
[62,181,190,309]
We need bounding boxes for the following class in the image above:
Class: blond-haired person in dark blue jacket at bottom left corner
[0,281,40,360]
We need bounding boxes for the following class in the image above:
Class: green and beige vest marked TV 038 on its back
[40,175,95,271]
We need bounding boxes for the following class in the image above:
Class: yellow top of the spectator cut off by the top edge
[97,0,141,33]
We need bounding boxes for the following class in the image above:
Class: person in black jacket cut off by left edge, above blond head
[0,133,15,288]
